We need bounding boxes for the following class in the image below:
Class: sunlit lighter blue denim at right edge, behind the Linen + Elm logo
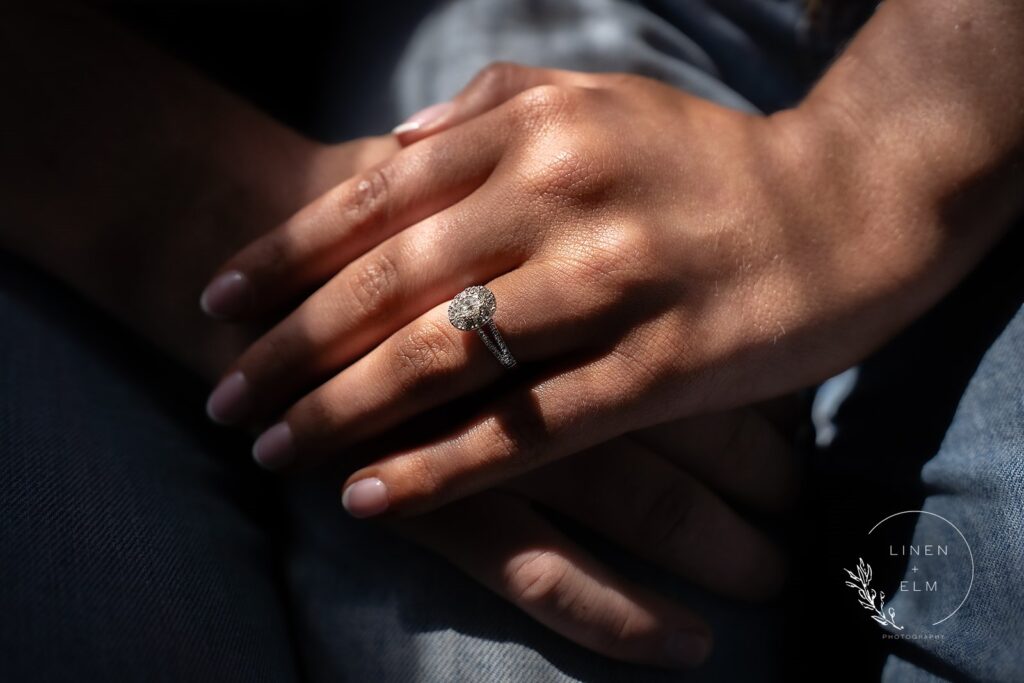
[883,309,1024,683]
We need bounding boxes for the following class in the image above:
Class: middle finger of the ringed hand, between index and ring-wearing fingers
[207,189,528,424]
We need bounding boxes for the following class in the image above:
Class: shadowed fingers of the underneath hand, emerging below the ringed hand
[387,410,797,667]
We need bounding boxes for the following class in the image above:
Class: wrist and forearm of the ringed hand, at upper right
[772,0,1024,317]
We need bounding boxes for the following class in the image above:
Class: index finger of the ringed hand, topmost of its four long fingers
[200,107,516,319]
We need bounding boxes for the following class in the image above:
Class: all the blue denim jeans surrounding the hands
[0,0,1024,681]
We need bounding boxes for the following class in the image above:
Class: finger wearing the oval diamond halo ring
[245,261,622,469]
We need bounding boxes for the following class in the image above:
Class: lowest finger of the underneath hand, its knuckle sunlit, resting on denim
[387,490,712,669]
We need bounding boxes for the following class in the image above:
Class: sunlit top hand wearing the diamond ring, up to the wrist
[201,66,958,516]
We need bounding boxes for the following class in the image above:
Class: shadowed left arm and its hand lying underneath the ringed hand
[0,3,797,667]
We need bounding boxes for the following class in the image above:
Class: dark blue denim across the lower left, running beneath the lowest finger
[0,266,781,682]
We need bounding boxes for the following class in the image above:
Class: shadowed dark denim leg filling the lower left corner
[0,258,298,682]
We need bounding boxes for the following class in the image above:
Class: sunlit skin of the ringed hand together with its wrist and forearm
[205,0,1024,656]
